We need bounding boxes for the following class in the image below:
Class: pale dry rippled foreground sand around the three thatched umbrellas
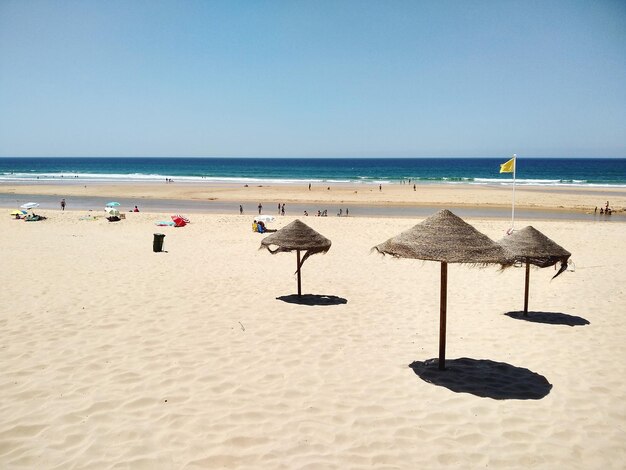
[0,207,626,469]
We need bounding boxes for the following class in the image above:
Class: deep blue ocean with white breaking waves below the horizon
[0,157,626,187]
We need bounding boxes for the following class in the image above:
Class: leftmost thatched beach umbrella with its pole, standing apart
[261,219,331,297]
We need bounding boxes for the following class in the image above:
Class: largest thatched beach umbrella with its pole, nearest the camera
[373,210,513,370]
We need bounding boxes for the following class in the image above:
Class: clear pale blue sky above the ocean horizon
[0,0,626,157]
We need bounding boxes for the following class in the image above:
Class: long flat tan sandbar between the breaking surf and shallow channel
[0,181,626,213]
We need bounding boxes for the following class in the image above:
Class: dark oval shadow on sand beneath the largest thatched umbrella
[409,357,552,400]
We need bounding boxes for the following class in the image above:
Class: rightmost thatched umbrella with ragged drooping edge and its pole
[499,225,571,316]
